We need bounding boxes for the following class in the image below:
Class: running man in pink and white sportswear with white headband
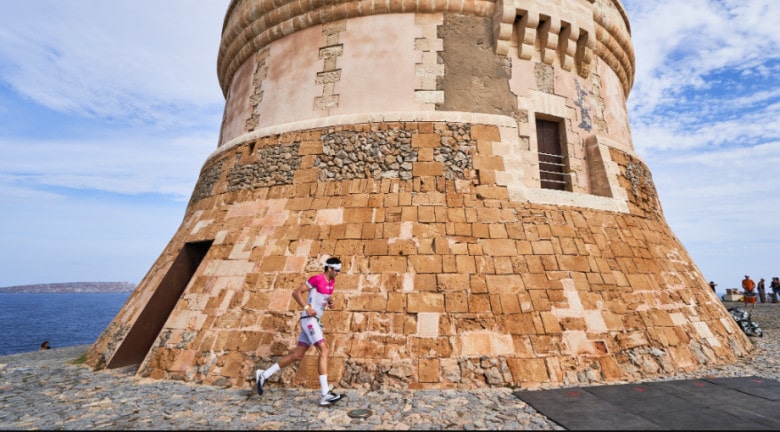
[255,258,343,406]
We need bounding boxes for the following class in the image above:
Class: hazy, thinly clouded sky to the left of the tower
[0,0,229,286]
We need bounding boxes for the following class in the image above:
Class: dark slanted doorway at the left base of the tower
[106,240,212,368]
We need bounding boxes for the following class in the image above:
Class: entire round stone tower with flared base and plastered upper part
[87,0,751,388]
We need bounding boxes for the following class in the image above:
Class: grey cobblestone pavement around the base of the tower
[0,303,780,430]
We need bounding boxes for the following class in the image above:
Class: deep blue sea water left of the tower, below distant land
[0,292,130,356]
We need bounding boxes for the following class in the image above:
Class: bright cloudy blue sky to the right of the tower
[623,0,780,291]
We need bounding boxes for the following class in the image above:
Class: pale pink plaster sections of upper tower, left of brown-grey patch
[220,14,423,141]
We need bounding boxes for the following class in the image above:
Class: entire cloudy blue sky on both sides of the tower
[0,0,780,293]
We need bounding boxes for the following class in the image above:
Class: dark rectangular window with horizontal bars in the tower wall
[536,119,568,190]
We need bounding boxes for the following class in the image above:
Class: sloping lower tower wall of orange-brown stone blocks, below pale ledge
[90,116,750,388]
